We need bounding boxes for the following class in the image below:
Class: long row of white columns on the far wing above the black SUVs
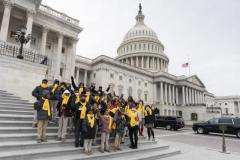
[157,82,204,106]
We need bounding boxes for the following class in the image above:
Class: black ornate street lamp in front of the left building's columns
[15,27,31,59]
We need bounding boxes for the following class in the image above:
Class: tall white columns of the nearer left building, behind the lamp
[0,0,77,80]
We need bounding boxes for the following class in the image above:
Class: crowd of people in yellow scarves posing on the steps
[32,77,158,154]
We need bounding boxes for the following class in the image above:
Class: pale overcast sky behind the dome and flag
[42,0,240,96]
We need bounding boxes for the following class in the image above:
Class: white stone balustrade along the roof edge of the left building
[39,4,79,26]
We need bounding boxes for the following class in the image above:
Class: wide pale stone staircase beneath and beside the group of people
[0,90,180,160]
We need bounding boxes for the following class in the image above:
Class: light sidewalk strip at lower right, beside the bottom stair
[158,140,240,160]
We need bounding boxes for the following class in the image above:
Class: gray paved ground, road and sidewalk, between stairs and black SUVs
[151,128,240,160]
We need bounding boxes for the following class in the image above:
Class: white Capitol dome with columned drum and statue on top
[116,4,169,72]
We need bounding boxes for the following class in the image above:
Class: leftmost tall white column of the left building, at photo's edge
[0,0,12,42]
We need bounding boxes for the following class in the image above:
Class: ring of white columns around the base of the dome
[120,56,168,72]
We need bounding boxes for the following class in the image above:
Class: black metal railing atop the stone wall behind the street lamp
[0,41,49,65]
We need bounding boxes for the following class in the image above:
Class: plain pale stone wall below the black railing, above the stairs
[0,56,47,101]
